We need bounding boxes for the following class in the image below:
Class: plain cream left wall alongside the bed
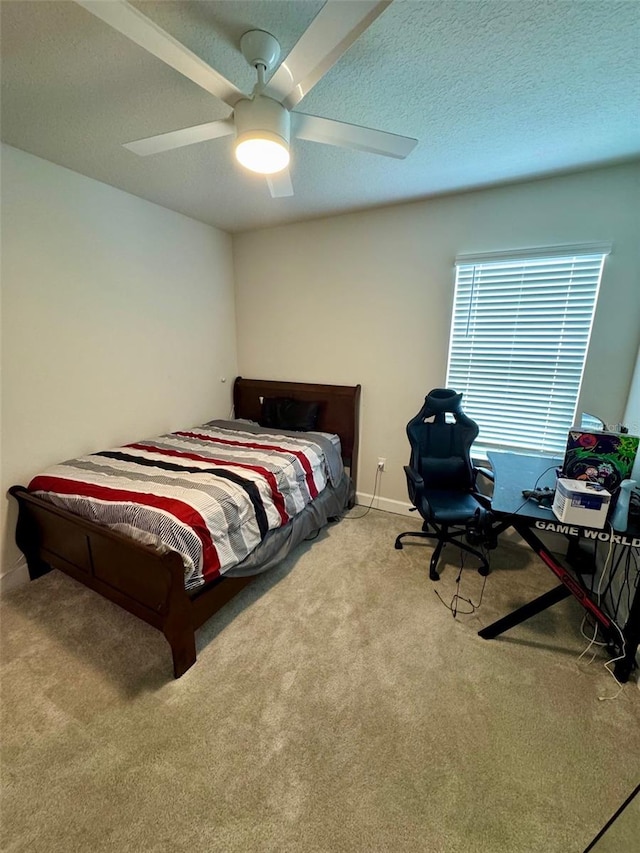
[0,146,236,586]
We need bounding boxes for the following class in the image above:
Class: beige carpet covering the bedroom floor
[1,507,640,853]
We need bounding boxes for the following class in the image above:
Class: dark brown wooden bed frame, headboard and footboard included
[9,377,360,678]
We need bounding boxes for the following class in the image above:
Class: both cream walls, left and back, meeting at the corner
[0,146,640,581]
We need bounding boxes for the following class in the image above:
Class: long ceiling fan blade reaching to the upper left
[76,0,244,107]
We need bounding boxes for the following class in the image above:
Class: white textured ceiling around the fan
[0,0,640,232]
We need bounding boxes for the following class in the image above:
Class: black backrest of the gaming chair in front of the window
[407,388,479,491]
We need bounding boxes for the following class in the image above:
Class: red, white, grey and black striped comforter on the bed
[29,424,340,589]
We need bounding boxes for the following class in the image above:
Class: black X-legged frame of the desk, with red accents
[478,452,640,683]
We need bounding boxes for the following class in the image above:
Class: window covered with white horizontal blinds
[447,246,610,454]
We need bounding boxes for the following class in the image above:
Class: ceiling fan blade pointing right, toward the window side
[291,113,418,160]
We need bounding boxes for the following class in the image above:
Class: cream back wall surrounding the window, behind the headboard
[233,163,640,511]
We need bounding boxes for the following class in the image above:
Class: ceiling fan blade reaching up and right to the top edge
[265,0,391,110]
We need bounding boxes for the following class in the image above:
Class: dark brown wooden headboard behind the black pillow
[233,376,360,486]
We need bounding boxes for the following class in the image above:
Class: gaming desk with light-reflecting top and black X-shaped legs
[478,451,640,682]
